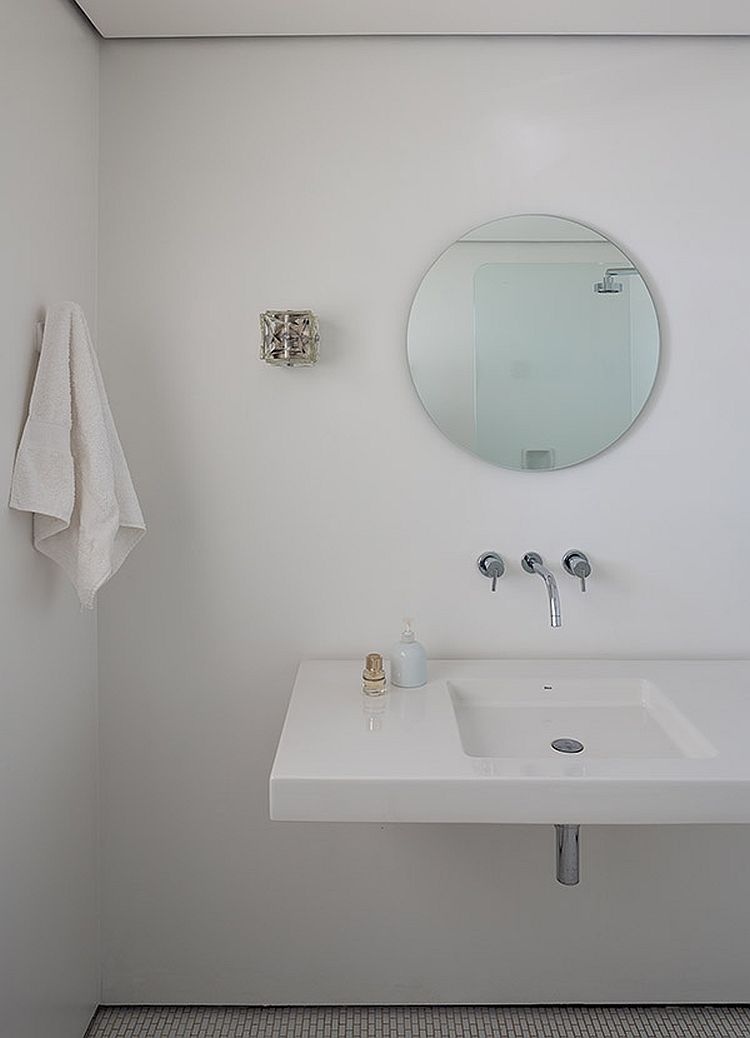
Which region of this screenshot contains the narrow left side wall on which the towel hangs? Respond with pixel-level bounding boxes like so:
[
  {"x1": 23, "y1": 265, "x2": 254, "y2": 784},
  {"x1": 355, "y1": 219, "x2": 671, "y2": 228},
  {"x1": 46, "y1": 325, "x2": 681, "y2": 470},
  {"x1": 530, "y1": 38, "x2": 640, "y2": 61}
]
[{"x1": 0, "y1": 0, "x2": 99, "y2": 1038}]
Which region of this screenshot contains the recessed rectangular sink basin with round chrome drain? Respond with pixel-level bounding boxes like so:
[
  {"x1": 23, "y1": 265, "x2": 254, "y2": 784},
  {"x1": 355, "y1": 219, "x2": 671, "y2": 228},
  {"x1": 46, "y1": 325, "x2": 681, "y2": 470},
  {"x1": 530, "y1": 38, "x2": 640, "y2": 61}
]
[{"x1": 447, "y1": 671, "x2": 716, "y2": 760}]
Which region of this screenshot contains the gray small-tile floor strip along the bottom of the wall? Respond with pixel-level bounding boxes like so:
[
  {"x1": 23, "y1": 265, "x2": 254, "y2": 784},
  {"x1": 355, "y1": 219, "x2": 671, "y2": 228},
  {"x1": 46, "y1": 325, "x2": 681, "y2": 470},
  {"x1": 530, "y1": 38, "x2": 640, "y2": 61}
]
[{"x1": 86, "y1": 1006, "x2": 750, "y2": 1038}]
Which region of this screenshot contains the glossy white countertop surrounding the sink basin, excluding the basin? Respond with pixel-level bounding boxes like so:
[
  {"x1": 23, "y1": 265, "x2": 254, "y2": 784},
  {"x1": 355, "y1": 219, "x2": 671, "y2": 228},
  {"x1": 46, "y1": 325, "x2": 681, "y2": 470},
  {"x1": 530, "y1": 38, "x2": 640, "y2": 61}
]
[{"x1": 270, "y1": 660, "x2": 750, "y2": 825}]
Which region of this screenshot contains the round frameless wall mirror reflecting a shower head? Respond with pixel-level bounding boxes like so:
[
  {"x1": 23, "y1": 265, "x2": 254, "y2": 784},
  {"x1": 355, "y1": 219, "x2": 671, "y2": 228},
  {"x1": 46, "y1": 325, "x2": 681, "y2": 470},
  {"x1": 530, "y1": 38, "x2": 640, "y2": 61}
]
[{"x1": 408, "y1": 216, "x2": 659, "y2": 469}]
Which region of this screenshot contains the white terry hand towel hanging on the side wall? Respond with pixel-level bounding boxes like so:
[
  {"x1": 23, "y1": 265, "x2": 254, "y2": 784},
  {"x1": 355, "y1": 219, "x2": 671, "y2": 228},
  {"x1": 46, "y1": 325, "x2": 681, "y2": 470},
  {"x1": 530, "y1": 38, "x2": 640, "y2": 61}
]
[{"x1": 10, "y1": 303, "x2": 146, "y2": 608}]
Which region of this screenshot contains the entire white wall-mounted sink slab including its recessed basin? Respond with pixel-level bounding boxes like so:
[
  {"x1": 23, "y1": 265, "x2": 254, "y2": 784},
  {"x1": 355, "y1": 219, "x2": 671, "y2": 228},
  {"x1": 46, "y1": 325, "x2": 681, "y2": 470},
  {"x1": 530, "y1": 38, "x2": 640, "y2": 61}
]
[{"x1": 271, "y1": 660, "x2": 750, "y2": 825}]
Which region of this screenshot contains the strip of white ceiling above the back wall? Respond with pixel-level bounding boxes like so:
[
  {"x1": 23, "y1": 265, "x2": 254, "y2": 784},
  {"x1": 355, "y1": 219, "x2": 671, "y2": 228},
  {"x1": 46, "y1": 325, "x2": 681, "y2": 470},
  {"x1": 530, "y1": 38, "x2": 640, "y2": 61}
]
[{"x1": 76, "y1": 0, "x2": 750, "y2": 38}]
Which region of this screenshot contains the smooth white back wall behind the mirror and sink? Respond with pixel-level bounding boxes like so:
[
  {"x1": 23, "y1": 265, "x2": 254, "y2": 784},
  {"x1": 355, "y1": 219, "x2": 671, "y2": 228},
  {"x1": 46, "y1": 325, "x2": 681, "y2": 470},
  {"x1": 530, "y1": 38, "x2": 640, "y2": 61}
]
[{"x1": 100, "y1": 39, "x2": 750, "y2": 1003}]
